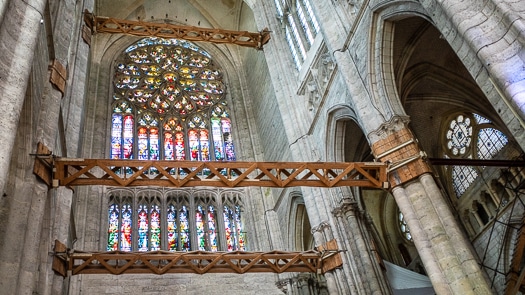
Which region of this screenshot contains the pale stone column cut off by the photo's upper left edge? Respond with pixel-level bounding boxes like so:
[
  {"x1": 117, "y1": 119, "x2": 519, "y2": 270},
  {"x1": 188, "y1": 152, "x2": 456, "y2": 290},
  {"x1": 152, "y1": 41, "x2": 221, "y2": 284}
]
[{"x1": 0, "y1": 0, "x2": 46, "y2": 194}]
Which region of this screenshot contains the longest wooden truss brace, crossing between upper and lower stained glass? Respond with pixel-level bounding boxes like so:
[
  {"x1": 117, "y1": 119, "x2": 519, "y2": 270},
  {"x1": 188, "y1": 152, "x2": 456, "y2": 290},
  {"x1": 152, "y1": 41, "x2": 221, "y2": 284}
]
[{"x1": 53, "y1": 158, "x2": 388, "y2": 188}]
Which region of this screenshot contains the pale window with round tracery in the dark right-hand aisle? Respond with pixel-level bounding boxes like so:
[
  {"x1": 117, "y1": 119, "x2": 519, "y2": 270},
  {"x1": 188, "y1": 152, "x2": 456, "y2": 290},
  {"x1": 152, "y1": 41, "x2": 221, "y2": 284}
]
[{"x1": 444, "y1": 113, "x2": 508, "y2": 198}]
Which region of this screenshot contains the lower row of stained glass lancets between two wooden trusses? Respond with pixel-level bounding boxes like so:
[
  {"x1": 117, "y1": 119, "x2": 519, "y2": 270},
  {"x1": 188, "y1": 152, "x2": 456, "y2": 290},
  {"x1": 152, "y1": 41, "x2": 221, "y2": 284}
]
[{"x1": 107, "y1": 189, "x2": 246, "y2": 251}]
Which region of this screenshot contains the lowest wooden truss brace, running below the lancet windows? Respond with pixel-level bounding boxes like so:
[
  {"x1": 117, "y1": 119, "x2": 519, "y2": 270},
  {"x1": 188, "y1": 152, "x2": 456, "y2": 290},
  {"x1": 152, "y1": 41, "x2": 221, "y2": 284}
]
[{"x1": 53, "y1": 240, "x2": 341, "y2": 277}]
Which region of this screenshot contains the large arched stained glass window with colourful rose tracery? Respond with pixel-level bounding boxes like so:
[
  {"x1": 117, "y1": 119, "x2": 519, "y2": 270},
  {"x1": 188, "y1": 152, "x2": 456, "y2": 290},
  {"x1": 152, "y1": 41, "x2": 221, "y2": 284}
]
[{"x1": 110, "y1": 38, "x2": 235, "y2": 161}]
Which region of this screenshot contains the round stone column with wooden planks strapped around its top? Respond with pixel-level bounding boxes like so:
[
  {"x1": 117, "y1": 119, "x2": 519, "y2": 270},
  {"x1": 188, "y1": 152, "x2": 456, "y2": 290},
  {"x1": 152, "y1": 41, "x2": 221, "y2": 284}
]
[{"x1": 369, "y1": 117, "x2": 492, "y2": 294}]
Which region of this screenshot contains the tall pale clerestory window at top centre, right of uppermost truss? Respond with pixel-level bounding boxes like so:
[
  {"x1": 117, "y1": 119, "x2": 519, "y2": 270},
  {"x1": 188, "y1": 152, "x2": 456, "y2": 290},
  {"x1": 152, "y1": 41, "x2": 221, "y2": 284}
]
[{"x1": 274, "y1": 0, "x2": 319, "y2": 69}]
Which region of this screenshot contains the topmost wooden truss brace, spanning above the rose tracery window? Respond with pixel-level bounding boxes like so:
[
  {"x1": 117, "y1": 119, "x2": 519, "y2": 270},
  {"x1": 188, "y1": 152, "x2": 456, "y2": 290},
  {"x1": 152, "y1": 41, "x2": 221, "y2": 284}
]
[{"x1": 84, "y1": 10, "x2": 270, "y2": 49}]
